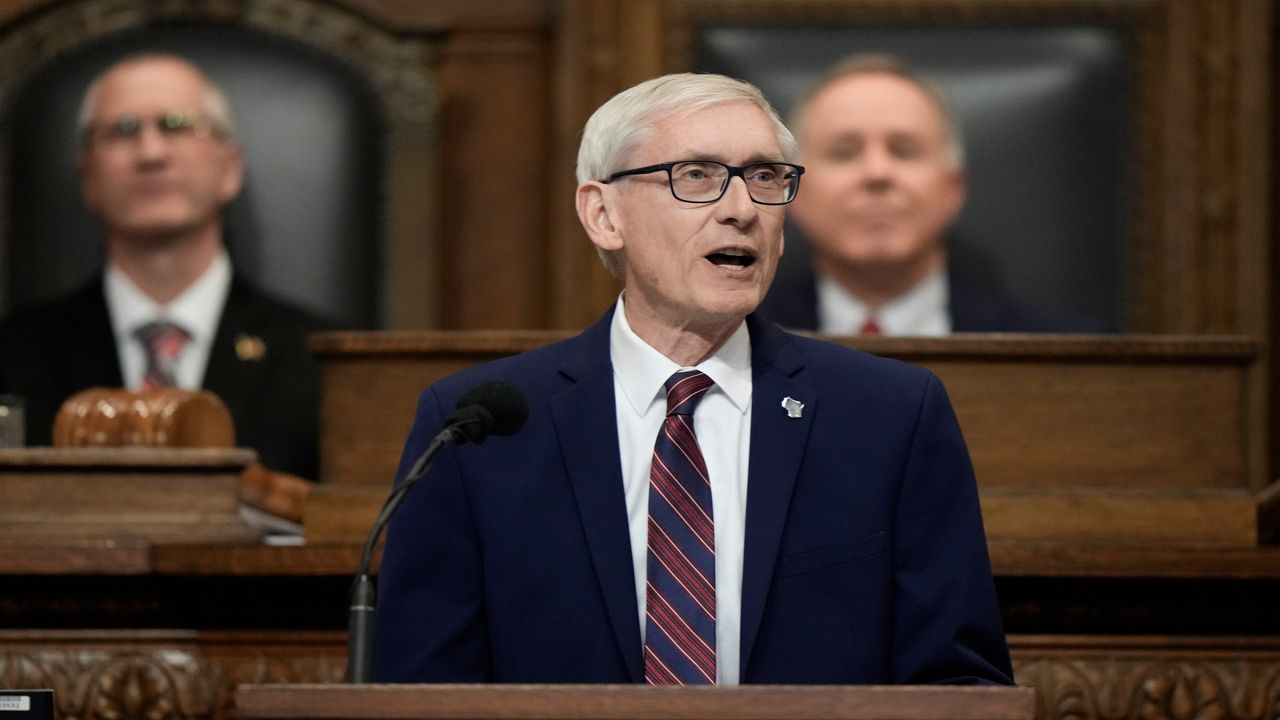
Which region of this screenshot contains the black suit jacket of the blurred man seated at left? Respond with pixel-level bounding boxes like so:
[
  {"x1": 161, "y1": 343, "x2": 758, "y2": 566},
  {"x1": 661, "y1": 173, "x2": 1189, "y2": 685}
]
[{"x1": 0, "y1": 275, "x2": 324, "y2": 479}]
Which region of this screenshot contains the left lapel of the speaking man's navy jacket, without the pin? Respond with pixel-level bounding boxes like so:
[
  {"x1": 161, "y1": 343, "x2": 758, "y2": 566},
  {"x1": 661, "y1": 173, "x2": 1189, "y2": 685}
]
[{"x1": 550, "y1": 311, "x2": 643, "y2": 682}]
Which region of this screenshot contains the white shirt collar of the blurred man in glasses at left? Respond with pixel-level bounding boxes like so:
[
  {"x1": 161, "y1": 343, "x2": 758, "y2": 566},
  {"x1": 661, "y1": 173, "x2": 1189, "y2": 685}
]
[{"x1": 102, "y1": 249, "x2": 232, "y2": 342}]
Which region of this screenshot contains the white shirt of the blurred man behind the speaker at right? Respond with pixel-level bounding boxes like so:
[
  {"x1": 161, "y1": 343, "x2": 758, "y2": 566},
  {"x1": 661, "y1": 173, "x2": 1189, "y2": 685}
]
[{"x1": 818, "y1": 270, "x2": 951, "y2": 337}]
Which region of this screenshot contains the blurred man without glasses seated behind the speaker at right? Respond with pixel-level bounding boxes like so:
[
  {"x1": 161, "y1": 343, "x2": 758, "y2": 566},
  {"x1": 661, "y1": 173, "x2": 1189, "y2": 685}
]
[{"x1": 759, "y1": 55, "x2": 1101, "y2": 336}]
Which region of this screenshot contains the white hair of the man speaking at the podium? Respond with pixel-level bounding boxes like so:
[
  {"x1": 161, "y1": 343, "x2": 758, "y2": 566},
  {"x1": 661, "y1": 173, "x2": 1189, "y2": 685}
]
[{"x1": 577, "y1": 73, "x2": 796, "y2": 277}]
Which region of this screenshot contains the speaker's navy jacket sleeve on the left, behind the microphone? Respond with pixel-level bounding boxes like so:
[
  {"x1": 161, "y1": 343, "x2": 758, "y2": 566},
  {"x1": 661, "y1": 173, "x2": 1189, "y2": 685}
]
[{"x1": 374, "y1": 389, "x2": 492, "y2": 683}]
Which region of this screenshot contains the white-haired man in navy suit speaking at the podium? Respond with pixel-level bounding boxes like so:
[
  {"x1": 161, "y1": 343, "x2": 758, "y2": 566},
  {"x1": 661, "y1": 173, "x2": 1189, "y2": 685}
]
[{"x1": 375, "y1": 74, "x2": 1012, "y2": 684}]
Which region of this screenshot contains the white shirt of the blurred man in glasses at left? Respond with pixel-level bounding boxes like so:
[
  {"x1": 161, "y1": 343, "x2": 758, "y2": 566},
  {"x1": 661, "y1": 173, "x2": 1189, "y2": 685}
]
[{"x1": 102, "y1": 250, "x2": 232, "y2": 389}]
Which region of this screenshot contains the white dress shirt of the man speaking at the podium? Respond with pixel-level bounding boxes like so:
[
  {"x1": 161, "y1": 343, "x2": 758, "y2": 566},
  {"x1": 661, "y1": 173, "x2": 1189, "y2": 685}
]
[{"x1": 609, "y1": 297, "x2": 751, "y2": 685}]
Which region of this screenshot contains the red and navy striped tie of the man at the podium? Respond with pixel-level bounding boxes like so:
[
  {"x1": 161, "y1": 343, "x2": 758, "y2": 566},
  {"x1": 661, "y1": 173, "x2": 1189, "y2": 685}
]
[{"x1": 644, "y1": 370, "x2": 716, "y2": 685}]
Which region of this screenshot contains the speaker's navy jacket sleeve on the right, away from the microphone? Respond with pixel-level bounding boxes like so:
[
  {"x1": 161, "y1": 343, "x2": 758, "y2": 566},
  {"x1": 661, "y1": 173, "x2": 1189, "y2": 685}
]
[{"x1": 892, "y1": 374, "x2": 1014, "y2": 684}]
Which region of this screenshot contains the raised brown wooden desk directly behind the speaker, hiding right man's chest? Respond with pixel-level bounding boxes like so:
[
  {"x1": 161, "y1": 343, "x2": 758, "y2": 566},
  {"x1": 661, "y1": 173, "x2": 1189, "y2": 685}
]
[{"x1": 311, "y1": 332, "x2": 1280, "y2": 546}]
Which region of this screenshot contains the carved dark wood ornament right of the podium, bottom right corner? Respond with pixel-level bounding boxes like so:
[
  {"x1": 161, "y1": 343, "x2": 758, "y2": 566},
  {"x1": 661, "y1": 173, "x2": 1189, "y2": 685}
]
[{"x1": 1014, "y1": 653, "x2": 1280, "y2": 720}]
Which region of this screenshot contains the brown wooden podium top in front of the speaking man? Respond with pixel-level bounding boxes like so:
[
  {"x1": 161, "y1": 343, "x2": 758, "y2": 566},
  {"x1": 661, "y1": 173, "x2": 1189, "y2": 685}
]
[{"x1": 236, "y1": 684, "x2": 1036, "y2": 720}]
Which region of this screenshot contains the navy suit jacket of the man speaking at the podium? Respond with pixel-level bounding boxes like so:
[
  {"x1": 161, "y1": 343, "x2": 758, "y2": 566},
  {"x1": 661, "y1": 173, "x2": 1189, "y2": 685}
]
[{"x1": 375, "y1": 304, "x2": 1011, "y2": 683}]
